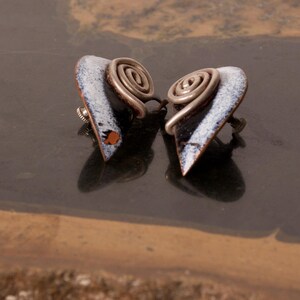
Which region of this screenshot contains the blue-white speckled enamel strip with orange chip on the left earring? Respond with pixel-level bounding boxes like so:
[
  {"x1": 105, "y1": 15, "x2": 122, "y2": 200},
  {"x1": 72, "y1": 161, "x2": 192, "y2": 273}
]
[{"x1": 75, "y1": 55, "x2": 130, "y2": 160}]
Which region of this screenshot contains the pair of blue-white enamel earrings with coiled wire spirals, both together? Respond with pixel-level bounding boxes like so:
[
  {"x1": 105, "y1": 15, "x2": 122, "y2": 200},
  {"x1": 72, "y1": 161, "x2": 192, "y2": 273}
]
[{"x1": 75, "y1": 56, "x2": 247, "y2": 176}]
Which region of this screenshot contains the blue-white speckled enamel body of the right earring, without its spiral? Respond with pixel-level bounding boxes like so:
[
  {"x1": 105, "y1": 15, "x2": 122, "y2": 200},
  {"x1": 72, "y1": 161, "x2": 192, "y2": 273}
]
[{"x1": 175, "y1": 67, "x2": 247, "y2": 175}]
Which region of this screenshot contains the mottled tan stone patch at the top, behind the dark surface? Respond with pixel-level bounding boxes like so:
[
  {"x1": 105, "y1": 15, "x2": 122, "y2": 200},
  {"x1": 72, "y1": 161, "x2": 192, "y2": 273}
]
[{"x1": 69, "y1": 0, "x2": 300, "y2": 41}]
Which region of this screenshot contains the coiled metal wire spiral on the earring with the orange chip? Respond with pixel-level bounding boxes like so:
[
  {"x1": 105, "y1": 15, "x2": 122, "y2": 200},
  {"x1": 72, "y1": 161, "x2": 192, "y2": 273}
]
[{"x1": 107, "y1": 58, "x2": 154, "y2": 118}]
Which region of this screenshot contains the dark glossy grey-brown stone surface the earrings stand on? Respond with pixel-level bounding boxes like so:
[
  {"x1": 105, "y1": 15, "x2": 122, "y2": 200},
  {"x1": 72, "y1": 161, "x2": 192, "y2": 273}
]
[{"x1": 0, "y1": 0, "x2": 300, "y2": 242}]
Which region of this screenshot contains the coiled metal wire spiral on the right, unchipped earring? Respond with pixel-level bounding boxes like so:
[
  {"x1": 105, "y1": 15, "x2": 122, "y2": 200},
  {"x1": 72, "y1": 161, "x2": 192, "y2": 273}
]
[{"x1": 165, "y1": 68, "x2": 220, "y2": 135}]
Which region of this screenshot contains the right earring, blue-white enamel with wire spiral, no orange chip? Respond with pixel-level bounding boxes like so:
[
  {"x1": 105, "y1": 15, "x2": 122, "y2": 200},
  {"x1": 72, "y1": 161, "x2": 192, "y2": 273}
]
[{"x1": 165, "y1": 67, "x2": 247, "y2": 176}]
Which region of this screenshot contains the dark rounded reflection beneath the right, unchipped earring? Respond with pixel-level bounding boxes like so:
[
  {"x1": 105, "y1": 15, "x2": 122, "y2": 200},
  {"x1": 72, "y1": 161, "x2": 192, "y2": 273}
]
[{"x1": 163, "y1": 131, "x2": 246, "y2": 202}]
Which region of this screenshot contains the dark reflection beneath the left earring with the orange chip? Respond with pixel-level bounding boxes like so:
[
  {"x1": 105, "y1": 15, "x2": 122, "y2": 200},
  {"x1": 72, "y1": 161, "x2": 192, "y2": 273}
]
[{"x1": 78, "y1": 110, "x2": 166, "y2": 192}]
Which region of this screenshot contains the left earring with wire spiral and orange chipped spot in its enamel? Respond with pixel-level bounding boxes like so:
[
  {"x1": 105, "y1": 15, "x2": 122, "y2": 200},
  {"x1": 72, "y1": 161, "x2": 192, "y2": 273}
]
[{"x1": 75, "y1": 56, "x2": 159, "y2": 161}]
